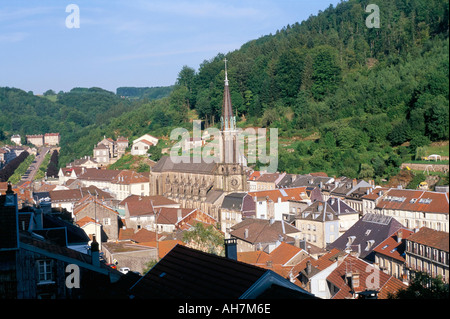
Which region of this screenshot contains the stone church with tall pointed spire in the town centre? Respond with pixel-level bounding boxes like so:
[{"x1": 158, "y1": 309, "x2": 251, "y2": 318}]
[{"x1": 150, "y1": 60, "x2": 247, "y2": 220}]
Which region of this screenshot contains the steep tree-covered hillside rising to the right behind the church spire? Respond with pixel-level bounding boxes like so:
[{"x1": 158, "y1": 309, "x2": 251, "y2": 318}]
[{"x1": 174, "y1": 0, "x2": 449, "y2": 178}]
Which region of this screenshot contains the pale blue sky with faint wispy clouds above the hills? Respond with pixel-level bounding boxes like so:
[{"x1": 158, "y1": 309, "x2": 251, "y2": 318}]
[{"x1": 0, "y1": 0, "x2": 340, "y2": 94}]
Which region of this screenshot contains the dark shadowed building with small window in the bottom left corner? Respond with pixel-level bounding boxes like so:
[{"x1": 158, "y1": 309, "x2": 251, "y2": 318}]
[{"x1": 0, "y1": 187, "x2": 125, "y2": 299}]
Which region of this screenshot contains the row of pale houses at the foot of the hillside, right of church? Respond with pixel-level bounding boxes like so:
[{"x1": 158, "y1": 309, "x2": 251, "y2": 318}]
[{"x1": 248, "y1": 172, "x2": 449, "y2": 232}]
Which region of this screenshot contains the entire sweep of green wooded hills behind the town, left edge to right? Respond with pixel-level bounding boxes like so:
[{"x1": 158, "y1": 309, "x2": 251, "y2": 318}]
[{"x1": 0, "y1": 0, "x2": 449, "y2": 179}]
